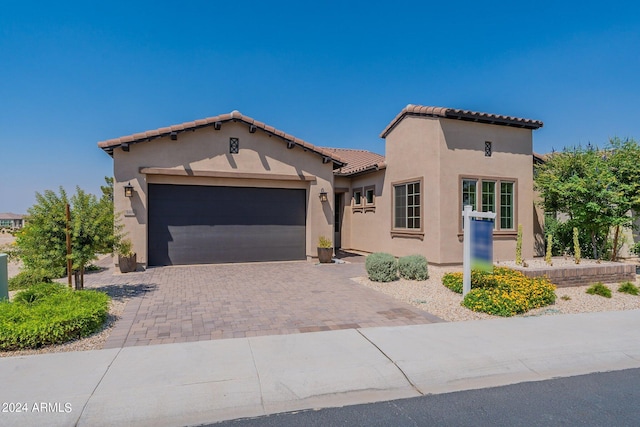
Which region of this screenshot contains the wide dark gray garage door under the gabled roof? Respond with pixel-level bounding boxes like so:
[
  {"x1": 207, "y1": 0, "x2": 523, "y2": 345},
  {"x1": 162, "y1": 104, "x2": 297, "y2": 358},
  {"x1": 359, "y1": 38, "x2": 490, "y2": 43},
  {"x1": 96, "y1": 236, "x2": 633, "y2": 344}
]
[{"x1": 147, "y1": 184, "x2": 306, "y2": 265}]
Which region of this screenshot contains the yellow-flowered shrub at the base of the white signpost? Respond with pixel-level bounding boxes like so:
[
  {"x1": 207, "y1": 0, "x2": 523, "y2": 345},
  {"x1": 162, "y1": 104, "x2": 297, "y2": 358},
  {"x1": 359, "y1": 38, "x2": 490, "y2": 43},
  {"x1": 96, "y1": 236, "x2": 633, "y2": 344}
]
[{"x1": 442, "y1": 267, "x2": 556, "y2": 316}]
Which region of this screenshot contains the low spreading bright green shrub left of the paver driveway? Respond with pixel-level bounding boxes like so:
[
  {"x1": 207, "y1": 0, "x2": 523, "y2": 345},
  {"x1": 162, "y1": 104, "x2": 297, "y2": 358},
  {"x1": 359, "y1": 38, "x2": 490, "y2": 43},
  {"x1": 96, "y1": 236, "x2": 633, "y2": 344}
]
[{"x1": 0, "y1": 285, "x2": 109, "y2": 350}]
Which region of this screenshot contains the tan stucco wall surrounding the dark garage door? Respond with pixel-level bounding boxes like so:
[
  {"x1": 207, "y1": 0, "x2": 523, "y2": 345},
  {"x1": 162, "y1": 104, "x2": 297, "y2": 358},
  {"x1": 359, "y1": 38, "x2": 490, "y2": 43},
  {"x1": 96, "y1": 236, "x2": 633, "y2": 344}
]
[{"x1": 113, "y1": 122, "x2": 334, "y2": 264}]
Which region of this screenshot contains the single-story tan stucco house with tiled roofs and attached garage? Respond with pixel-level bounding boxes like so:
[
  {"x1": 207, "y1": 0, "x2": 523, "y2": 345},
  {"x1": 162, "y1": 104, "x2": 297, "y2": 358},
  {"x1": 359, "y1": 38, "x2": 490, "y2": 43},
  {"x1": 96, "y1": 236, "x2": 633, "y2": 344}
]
[{"x1": 98, "y1": 105, "x2": 543, "y2": 266}]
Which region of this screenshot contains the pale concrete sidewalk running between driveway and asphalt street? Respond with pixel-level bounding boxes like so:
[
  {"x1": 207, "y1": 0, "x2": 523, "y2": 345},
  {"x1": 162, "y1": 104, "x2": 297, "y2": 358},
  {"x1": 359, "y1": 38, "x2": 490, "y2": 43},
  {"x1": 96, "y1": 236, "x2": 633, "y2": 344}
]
[{"x1": 0, "y1": 310, "x2": 640, "y2": 426}]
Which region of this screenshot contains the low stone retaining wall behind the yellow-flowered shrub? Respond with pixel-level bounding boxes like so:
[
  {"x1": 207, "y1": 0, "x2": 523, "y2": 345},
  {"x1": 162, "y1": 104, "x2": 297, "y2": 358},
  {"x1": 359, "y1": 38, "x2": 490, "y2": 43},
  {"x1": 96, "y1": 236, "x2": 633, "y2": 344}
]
[{"x1": 511, "y1": 262, "x2": 636, "y2": 288}]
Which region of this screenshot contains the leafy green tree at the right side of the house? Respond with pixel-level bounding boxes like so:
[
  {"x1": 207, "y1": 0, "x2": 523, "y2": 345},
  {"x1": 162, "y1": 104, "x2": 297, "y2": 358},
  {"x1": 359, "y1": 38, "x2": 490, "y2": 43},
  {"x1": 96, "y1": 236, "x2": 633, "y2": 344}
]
[{"x1": 535, "y1": 139, "x2": 640, "y2": 259}]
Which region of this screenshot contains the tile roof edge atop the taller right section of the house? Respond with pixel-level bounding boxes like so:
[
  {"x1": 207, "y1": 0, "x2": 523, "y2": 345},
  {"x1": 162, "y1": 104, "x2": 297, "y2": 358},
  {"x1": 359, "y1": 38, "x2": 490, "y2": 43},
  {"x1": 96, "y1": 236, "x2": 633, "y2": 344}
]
[{"x1": 380, "y1": 104, "x2": 543, "y2": 138}]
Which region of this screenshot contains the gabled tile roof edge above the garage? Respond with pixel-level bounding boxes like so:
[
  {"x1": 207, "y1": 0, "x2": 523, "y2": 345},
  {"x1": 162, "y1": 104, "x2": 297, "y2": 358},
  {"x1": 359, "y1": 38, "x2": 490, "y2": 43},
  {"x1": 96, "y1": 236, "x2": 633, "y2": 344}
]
[{"x1": 98, "y1": 110, "x2": 346, "y2": 166}]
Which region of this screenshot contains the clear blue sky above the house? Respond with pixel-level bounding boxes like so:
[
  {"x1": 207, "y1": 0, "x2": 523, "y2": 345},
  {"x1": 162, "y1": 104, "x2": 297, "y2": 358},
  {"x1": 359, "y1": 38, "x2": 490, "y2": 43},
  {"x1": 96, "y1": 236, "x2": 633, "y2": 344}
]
[{"x1": 0, "y1": 0, "x2": 640, "y2": 213}]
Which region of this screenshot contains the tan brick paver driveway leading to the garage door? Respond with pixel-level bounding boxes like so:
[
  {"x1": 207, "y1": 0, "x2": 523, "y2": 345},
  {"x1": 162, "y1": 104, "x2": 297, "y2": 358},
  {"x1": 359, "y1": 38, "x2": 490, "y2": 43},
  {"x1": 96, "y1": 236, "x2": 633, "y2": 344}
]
[{"x1": 85, "y1": 261, "x2": 442, "y2": 348}]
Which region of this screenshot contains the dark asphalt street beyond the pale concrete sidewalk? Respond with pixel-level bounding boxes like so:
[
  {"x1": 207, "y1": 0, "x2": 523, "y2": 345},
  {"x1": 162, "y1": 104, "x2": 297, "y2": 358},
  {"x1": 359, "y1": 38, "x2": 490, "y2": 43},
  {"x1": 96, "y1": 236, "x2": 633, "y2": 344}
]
[{"x1": 211, "y1": 369, "x2": 640, "y2": 427}]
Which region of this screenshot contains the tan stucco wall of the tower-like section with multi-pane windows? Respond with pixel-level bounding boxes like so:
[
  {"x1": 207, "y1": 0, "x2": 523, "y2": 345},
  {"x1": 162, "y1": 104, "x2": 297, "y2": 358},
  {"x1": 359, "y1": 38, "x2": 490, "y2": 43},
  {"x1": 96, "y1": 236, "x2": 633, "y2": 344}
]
[{"x1": 344, "y1": 116, "x2": 534, "y2": 264}]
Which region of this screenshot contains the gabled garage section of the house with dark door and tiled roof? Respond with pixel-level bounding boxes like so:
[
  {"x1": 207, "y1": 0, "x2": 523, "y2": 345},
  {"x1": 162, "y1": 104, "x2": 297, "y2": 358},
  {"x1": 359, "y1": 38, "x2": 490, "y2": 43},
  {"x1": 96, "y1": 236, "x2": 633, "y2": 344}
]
[{"x1": 98, "y1": 111, "x2": 346, "y2": 268}]
